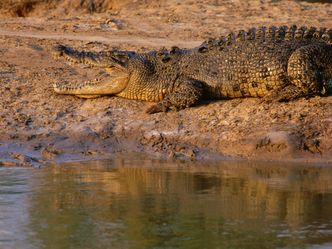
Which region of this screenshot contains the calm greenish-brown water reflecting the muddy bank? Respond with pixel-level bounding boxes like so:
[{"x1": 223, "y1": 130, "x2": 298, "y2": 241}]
[{"x1": 0, "y1": 159, "x2": 332, "y2": 249}]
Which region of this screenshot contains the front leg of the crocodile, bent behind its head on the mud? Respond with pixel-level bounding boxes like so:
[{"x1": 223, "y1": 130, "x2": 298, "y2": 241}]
[{"x1": 146, "y1": 77, "x2": 203, "y2": 114}]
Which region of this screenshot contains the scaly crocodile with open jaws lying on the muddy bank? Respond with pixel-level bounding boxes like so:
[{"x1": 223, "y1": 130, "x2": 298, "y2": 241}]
[{"x1": 53, "y1": 25, "x2": 332, "y2": 113}]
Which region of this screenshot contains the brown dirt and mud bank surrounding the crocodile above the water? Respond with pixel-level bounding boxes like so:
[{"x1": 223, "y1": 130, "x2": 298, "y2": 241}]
[{"x1": 0, "y1": 0, "x2": 332, "y2": 166}]
